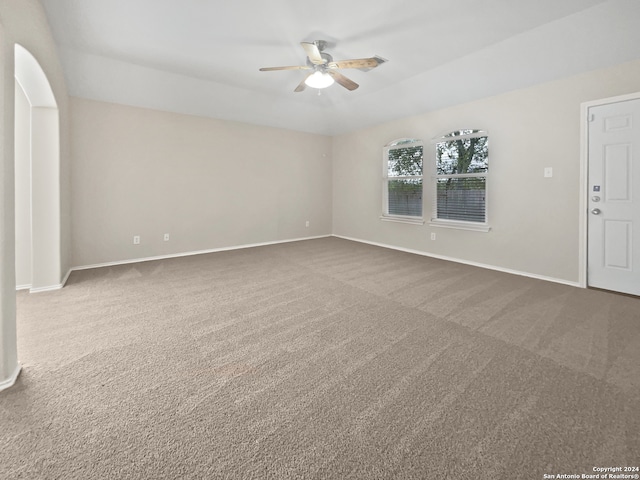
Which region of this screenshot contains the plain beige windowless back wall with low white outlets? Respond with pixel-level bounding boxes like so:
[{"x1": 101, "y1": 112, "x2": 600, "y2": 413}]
[{"x1": 71, "y1": 98, "x2": 332, "y2": 266}]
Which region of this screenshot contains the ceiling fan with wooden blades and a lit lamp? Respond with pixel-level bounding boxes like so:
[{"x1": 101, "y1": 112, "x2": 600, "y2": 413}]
[{"x1": 260, "y1": 40, "x2": 386, "y2": 93}]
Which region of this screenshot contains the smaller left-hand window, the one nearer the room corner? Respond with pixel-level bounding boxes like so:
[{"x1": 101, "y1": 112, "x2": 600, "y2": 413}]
[{"x1": 381, "y1": 138, "x2": 423, "y2": 223}]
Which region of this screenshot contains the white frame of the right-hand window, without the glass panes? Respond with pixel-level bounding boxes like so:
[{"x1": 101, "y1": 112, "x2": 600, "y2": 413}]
[{"x1": 429, "y1": 128, "x2": 491, "y2": 232}]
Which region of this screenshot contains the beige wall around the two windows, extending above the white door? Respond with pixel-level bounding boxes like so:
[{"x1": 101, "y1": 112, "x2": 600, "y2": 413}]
[{"x1": 333, "y1": 61, "x2": 640, "y2": 283}]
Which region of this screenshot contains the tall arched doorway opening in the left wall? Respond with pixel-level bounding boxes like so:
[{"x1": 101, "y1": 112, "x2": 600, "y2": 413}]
[{"x1": 15, "y1": 44, "x2": 61, "y2": 292}]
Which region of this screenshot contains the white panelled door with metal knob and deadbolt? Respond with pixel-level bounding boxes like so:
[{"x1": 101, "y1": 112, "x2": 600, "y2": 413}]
[{"x1": 587, "y1": 99, "x2": 640, "y2": 295}]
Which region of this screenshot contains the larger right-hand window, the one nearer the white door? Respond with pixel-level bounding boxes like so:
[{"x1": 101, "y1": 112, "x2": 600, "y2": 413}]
[{"x1": 431, "y1": 130, "x2": 489, "y2": 231}]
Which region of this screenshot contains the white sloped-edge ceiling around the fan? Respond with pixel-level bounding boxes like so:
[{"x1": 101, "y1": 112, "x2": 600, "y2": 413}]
[{"x1": 41, "y1": 0, "x2": 640, "y2": 135}]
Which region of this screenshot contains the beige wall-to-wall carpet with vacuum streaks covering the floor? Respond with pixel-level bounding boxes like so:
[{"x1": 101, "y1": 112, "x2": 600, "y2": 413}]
[{"x1": 0, "y1": 238, "x2": 640, "y2": 480}]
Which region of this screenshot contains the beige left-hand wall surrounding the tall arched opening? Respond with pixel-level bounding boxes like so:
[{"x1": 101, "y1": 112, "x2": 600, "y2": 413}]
[{"x1": 0, "y1": 0, "x2": 71, "y2": 388}]
